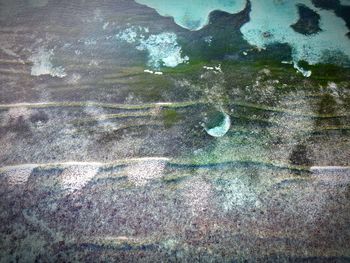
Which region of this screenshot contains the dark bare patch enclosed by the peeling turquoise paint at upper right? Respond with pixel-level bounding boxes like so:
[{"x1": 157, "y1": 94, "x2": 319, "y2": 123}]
[{"x1": 291, "y1": 4, "x2": 322, "y2": 35}]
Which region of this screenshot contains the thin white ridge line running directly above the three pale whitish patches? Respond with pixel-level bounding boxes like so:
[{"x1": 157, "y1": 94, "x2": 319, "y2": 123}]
[{"x1": 0, "y1": 157, "x2": 170, "y2": 172}]
